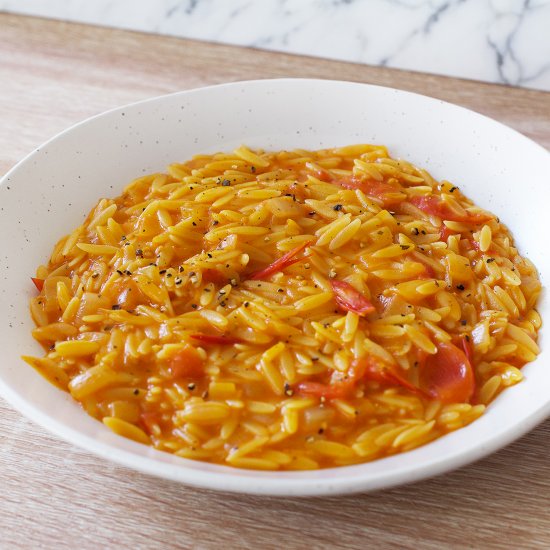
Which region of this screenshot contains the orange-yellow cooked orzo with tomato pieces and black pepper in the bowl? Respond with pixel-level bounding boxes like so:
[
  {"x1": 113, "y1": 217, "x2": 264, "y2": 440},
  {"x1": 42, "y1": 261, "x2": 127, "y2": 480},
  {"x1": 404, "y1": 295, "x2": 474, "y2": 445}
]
[{"x1": 25, "y1": 145, "x2": 541, "y2": 470}]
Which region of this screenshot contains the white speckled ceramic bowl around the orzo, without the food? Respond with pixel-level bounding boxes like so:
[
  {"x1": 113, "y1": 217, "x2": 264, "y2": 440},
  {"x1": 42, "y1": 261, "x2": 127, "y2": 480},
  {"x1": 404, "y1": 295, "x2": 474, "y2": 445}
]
[{"x1": 0, "y1": 79, "x2": 550, "y2": 495}]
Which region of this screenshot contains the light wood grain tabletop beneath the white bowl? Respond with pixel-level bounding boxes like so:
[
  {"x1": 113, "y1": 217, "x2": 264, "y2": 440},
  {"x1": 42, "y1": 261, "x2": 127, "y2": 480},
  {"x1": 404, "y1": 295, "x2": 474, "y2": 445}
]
[{"x1": 0, "y1": 14, "x2": 550, "y2": 549}]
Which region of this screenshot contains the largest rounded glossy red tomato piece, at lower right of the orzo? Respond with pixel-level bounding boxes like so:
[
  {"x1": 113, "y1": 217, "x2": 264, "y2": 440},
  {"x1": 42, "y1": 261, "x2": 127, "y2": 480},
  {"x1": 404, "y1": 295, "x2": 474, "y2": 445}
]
[{"x1": 420, "y1": 339, "x2": 475, "y2": 403}]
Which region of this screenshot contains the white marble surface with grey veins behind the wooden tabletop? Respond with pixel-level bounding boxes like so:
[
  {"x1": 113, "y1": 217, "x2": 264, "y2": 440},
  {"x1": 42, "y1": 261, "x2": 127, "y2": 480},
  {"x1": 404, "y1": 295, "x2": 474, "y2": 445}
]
[{"x1": 0, "y1": 0, "x2": 550, "y2": 91}]
